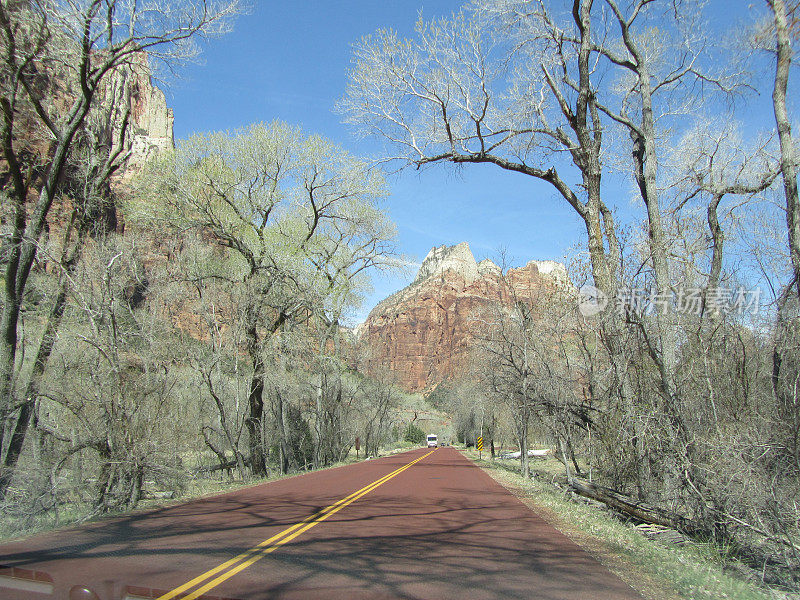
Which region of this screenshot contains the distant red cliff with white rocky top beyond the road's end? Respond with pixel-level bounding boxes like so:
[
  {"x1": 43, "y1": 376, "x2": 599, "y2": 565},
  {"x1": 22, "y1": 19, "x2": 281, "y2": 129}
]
[{"x1": 358, "y1": 242, "x2": 567, "y2": 392}]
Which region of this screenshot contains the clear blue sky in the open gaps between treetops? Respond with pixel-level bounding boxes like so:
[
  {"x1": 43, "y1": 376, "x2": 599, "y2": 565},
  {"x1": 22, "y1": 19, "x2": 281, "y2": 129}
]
[{"x1": 167, "y1": 0, "x2": 780, "y2": 320}]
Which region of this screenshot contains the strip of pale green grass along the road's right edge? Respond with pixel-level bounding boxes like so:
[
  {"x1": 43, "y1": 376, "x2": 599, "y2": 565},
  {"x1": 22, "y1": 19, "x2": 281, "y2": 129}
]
[{"x1": 464, "y1": 450, "x2": 800, "y2": 600}]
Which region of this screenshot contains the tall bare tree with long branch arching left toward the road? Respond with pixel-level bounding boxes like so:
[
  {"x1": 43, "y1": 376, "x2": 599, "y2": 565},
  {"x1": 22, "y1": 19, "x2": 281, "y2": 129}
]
[{"x1": 340, "y1": 2, "x2": 619, "y2": 294}]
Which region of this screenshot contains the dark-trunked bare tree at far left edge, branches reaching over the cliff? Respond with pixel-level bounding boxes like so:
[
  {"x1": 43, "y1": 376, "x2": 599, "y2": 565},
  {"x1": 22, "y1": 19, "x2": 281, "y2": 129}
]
[{"x1": 0, "y1": 0, "x2": 240, "y2": 496}]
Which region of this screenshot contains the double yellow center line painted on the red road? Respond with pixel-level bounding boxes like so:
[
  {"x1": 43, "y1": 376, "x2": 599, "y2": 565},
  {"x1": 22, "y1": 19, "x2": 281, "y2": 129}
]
[{"x1": 156, "y1": 450, "x2": 434, "y2": 600}]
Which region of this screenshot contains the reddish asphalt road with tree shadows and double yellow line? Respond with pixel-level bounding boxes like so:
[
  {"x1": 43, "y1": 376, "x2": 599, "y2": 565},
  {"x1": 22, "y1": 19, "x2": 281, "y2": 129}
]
[{"x1": 0, "y1": 448, "x2": 641, "y2": 600}]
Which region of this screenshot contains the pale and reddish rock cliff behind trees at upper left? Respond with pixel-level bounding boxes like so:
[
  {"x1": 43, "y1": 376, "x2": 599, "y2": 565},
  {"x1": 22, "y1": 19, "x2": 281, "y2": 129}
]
[{"x1": 0, "y1": 52, "x2": 174, "y2": 241}]
